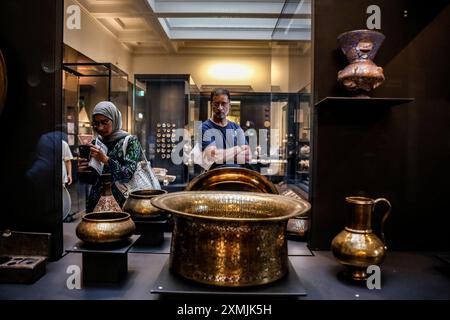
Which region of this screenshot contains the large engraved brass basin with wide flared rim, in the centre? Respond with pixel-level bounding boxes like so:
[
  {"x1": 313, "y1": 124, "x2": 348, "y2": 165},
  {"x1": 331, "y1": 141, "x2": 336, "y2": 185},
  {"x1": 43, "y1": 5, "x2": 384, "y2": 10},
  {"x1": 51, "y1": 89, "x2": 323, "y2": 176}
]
[{"x1": 152, "y1": 191, "x2": 310, "y2": 287}]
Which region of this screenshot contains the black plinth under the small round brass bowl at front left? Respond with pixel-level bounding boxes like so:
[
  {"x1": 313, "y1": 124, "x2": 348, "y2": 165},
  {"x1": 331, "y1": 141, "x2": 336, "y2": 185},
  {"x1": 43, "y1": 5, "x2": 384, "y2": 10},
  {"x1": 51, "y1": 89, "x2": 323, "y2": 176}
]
[{"x1": 67, "y1": 235, "x2": 139, "y2": 283}]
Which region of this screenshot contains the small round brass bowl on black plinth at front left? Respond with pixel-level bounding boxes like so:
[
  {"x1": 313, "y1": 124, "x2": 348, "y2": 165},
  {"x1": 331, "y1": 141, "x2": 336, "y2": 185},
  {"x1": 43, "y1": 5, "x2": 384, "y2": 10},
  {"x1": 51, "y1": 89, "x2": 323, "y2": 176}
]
[{"x1": 76, "y1": 211, "x2": 135, "y2": 244}]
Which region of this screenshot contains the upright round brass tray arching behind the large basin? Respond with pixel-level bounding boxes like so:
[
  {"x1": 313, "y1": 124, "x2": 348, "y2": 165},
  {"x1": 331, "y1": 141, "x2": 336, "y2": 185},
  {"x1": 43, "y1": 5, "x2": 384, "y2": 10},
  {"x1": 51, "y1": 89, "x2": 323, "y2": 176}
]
[{"x1": 185, "y1": 167, "x2": 279, "y2": 194}]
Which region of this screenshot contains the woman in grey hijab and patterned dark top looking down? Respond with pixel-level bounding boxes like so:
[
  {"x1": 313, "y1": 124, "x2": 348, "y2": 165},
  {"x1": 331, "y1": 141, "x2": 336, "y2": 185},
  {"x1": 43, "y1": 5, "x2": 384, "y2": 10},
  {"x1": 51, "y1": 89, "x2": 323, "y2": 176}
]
[{"x1": 79, "y1": 101, "x2": 141, "y2": 212}]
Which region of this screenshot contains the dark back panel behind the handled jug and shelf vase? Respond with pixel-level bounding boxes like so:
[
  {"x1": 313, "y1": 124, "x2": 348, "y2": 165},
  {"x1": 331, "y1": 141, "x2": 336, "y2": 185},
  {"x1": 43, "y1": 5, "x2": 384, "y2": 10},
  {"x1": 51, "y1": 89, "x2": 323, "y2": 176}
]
[{"x1": 310, "y1": 0, "x2": 450, "y2": 251}]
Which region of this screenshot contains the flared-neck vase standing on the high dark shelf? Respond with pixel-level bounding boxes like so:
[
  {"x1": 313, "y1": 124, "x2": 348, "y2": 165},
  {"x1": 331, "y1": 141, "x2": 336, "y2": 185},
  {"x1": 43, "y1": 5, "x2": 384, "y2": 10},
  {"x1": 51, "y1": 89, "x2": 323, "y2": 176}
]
[{"x1": 337, "y1": 30, "x2": 385, "y2": 96}]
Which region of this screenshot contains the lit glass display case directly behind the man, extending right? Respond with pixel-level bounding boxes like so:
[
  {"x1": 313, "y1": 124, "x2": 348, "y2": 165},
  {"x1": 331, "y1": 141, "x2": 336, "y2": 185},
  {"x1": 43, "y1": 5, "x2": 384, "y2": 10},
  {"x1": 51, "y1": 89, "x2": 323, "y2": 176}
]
[{"x1": 186, "y1": 91, "x2": 310, "y2": 192}]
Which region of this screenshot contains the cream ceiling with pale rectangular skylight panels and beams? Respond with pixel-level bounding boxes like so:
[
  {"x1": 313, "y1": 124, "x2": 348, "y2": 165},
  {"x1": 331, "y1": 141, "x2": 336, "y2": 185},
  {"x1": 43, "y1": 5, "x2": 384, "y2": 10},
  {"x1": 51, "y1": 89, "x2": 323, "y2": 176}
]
[{"x1": 78, "y1": 0, "x2": 311, "y2": 55}]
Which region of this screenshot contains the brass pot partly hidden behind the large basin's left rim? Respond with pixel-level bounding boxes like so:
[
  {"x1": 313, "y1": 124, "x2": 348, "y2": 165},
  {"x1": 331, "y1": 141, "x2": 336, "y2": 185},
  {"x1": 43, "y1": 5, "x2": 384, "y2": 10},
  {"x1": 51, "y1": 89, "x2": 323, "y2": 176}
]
[{"x1": 122, "y1": 189, "x2": 167, "y2": 219}]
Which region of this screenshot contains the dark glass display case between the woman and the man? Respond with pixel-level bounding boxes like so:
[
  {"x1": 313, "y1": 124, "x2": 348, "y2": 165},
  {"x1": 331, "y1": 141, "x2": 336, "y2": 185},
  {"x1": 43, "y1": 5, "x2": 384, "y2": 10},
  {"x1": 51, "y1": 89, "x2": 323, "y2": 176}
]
[{"x1": 133, "y1": 74, "x2": 199, "y2": 189}]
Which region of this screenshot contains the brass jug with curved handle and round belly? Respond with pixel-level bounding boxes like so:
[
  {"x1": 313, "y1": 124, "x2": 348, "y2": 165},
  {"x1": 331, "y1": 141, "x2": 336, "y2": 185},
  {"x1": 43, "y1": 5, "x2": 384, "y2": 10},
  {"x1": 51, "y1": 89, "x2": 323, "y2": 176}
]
[{"x1": 331, "y1": 197, "x2": 391, "y2": 280}]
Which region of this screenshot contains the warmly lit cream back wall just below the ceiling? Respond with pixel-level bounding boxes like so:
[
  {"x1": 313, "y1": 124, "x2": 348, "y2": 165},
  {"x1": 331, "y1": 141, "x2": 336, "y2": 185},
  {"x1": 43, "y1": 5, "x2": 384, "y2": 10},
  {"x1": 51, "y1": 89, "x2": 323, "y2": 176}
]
[{"x1": 133, "y1": 50, "x2": 311, "y2": 92}]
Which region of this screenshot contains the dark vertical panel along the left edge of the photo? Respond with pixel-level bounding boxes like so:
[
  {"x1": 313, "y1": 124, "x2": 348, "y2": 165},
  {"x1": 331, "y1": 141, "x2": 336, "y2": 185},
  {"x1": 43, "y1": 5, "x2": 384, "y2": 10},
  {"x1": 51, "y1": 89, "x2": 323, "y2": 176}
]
[{"x1": 0, "y1": 0, "x2": 64, "y2": 258}]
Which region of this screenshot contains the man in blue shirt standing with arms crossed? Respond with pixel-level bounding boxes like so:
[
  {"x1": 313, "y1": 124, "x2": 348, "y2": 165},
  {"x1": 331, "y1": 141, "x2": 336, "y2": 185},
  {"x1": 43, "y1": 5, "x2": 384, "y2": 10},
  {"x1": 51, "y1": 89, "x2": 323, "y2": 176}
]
[{"x1": 201, "y1": 88, "x2": 250, "y2": 169}]
